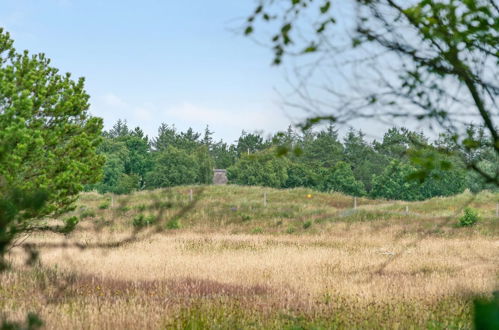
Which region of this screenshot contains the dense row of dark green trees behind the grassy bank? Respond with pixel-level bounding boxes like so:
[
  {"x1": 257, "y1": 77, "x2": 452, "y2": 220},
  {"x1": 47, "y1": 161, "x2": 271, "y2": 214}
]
[{"x1": 86, "y1": 120, "x2": 497, "y2": 200}]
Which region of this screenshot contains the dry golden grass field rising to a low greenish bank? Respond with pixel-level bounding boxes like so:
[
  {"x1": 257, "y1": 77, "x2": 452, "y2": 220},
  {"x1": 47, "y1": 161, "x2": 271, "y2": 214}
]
[{"x1": 0, "y1": 186, "x2": 499, "y2": 329}]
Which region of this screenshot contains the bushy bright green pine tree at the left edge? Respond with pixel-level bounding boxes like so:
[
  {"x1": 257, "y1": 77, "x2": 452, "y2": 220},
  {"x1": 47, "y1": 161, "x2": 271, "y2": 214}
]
[{"x1": 0, "y1": 29, "x2": 103, "y2": 218}]
